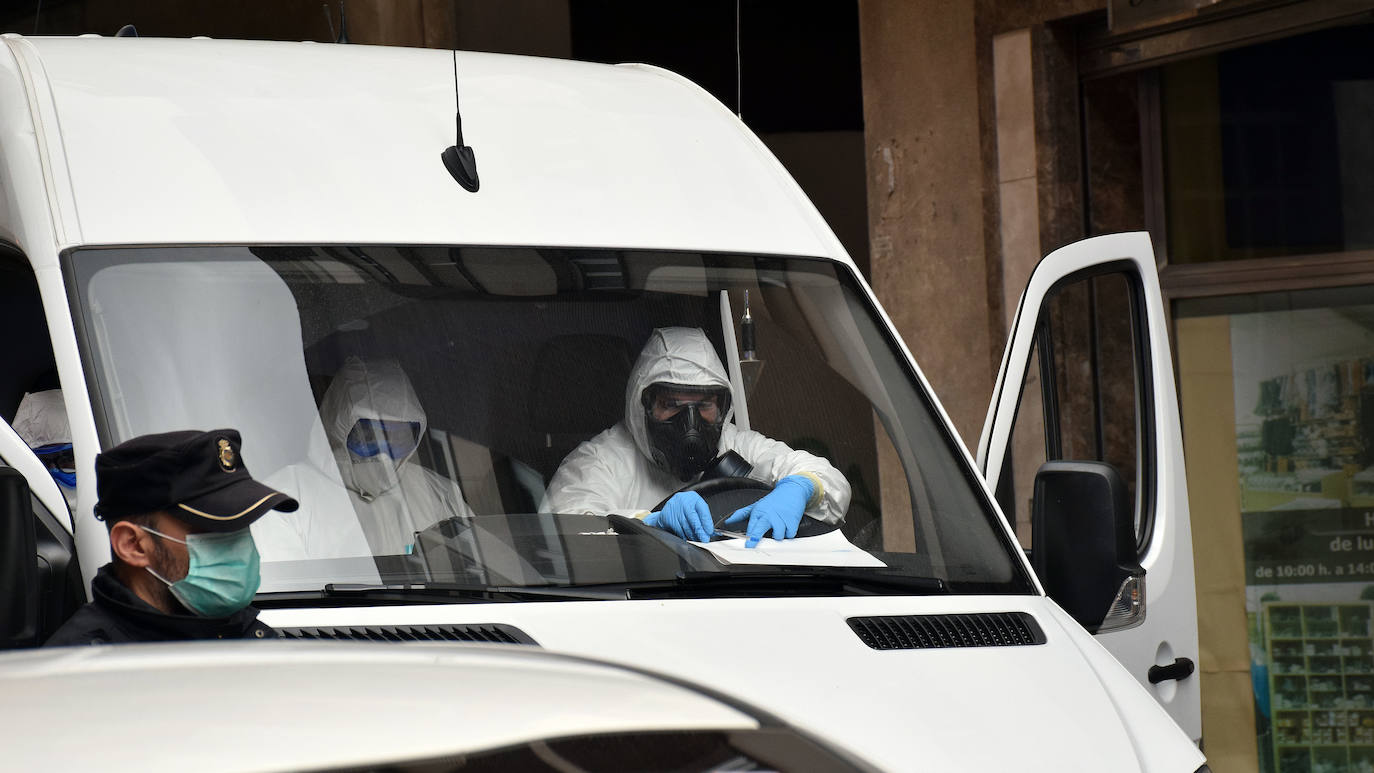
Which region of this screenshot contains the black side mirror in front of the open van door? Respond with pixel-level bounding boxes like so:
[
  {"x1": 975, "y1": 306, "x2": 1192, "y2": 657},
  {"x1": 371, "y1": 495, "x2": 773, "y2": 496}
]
[{"x1": 1031, "y1": 461, "x2": 1145, "y2": 632}]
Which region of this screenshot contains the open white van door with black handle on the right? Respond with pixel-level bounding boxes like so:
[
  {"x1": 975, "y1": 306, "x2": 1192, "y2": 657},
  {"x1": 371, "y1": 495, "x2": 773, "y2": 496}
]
[{"x1": 978, "y1": 233, "x2": 1202, "y2": 740}]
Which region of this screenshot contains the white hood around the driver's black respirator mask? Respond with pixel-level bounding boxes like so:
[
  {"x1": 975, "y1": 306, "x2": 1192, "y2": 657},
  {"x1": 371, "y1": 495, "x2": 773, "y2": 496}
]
[{"x1": 625, "y1": 327, "x2": 735, "y2": 459}]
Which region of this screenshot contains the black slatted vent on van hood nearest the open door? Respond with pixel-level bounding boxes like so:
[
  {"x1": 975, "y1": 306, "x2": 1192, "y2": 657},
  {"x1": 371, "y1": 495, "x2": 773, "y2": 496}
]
[{"x1": 848, "y1": 612, "x2": 1044, "y2": 649}]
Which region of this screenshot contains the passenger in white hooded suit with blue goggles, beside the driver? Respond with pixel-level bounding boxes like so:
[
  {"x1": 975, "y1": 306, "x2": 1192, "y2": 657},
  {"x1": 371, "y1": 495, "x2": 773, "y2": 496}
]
[{"x1": 320, "y1": 357, "x2": 473, "y2": 556}]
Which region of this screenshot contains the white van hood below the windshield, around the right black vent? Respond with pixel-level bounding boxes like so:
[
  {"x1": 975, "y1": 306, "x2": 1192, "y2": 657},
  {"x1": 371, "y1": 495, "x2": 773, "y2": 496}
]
[{"x1": 262, "y1": 596, "x2": 1204, "y2": 773}]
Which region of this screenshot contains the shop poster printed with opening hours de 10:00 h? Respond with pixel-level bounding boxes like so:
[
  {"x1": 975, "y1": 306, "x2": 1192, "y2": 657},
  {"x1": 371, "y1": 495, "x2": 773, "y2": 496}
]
[{"x1": 1231, "y1": 306, "x2": 1374, "y2": 773}]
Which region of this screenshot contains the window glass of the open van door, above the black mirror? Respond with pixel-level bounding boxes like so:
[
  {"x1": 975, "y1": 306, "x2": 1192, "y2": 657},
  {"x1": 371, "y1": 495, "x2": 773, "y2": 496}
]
[{"x1": 998, "y1": 273, "x2": 1151, "y2": 546}]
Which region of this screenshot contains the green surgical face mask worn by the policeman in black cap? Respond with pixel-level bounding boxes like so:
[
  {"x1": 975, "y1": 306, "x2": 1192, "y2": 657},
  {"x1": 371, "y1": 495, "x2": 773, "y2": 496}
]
[{"x1": 143, "y1": 526, "x2": 262, "y2": 618}]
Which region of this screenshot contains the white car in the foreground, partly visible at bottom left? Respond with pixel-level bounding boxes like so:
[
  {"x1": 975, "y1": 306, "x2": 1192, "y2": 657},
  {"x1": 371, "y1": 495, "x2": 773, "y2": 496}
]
[{"x1": 0, "y1": 641, "x2": 874, "y2": 773}]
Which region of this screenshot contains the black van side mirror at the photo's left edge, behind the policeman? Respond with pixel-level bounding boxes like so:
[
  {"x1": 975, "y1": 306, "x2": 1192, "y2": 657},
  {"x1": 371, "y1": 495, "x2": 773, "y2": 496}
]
[{"x1": 0, "y1": 467, "x2": 38, "y2": 649}]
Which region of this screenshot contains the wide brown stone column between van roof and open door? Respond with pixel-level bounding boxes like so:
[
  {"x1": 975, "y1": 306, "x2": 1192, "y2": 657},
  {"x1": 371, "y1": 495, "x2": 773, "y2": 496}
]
[{"x1": 859, "y1": 0, "x2": 1002, "y2": 446}]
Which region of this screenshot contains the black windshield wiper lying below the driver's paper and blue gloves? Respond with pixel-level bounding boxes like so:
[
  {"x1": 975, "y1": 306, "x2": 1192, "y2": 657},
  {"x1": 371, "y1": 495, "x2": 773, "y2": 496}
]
[{"x1": 596, "y1": 567, "x2": 945, "y2": 599}]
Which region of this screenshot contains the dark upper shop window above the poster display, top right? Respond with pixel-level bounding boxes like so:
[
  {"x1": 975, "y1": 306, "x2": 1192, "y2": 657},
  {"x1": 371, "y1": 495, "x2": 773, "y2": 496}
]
[{"x1": 1161, "y1": 25, "x2": 1374, "y2": 264}]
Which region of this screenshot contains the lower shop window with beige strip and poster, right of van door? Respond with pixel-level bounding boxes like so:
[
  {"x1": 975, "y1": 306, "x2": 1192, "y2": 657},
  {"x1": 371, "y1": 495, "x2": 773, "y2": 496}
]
[{"x1": 1175, "y1": 287, "x2": 1374, "y2": 772}]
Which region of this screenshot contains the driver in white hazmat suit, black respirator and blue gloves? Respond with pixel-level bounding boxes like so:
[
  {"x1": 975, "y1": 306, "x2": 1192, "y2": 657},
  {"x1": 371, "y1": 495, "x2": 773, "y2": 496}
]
[{"x1": 540, "y1": 327, "x2": 849, "y2": 546}]
